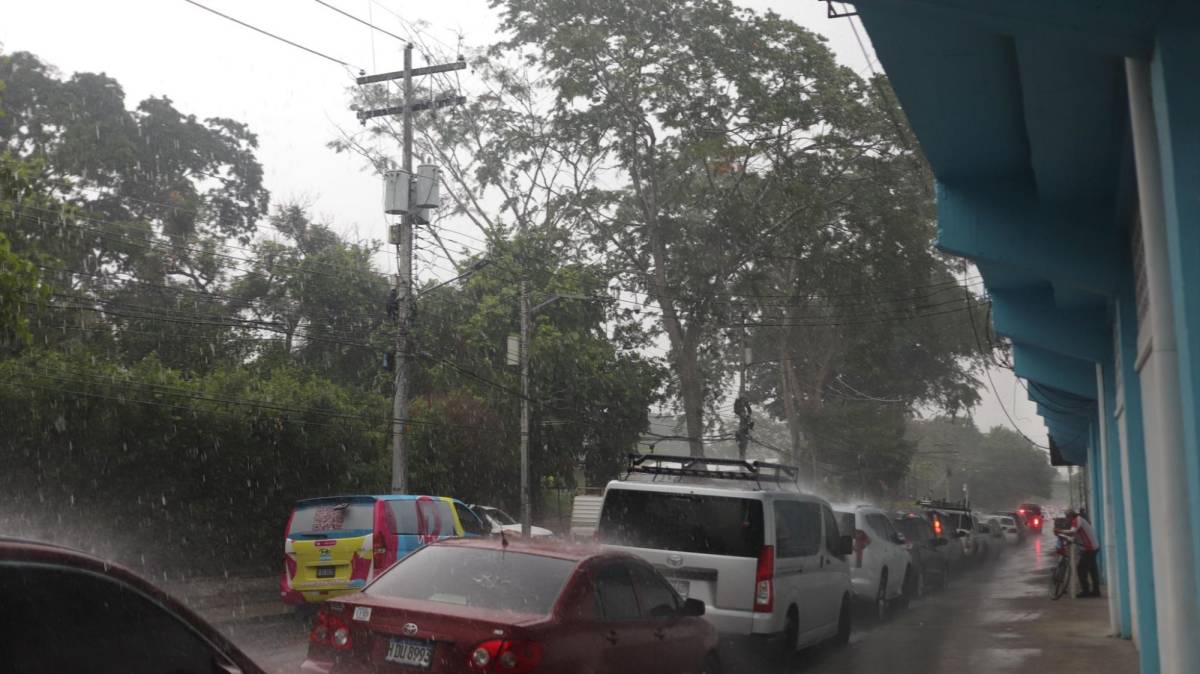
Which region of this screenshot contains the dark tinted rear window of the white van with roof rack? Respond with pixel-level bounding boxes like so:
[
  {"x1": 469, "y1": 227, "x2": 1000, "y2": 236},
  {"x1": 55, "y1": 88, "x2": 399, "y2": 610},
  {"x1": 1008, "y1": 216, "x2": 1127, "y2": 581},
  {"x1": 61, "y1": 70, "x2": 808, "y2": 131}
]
[{"x1": 598, "y1": 489, "x2": 763, "y2": 558}]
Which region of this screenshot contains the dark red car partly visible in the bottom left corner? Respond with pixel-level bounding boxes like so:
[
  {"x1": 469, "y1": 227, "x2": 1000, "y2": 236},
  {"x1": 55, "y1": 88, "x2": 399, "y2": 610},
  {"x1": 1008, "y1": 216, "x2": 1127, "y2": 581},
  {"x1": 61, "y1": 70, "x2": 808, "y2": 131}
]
[{"x1": 0, "y1": 538, "x2": 263, "y2": 674}]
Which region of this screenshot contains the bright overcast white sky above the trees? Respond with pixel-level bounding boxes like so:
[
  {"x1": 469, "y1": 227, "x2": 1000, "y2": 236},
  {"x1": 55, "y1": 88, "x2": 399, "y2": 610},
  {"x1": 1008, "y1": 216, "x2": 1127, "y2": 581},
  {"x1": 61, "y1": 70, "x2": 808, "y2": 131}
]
[{"x1": 0, "y1": 0, "x2": 1045, "y2": 443}]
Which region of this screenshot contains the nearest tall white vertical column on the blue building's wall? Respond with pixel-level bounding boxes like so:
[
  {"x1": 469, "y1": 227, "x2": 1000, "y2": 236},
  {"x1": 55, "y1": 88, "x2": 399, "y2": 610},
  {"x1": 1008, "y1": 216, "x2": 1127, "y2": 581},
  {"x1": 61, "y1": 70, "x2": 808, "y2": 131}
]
[{"x1": 1126, "y1": 59, "x2": 1200, "y2": 674}]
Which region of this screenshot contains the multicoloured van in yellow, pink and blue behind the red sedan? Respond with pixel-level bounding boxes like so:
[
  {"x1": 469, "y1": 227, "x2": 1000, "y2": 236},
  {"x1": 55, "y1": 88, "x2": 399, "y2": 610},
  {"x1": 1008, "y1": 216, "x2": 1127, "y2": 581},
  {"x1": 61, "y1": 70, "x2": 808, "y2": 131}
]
[{"x1": 280, "y1": 494, "x2": 491, "y2": 606}]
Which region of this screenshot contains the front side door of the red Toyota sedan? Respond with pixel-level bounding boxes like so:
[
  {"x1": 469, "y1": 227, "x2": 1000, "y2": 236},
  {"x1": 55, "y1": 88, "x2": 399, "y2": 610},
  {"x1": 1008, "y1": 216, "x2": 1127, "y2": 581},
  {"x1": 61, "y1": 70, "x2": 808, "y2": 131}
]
[{"x1": 629, "y1": 561, "x2": 686, "y2": 674}]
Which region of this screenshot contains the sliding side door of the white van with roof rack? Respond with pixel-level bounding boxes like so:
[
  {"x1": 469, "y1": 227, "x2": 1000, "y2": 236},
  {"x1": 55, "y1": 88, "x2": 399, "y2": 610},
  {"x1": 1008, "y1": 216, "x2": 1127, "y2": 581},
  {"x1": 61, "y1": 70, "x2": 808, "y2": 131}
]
[{"x1": 774, "y1": 500, "x2": 827, "y2": 643}]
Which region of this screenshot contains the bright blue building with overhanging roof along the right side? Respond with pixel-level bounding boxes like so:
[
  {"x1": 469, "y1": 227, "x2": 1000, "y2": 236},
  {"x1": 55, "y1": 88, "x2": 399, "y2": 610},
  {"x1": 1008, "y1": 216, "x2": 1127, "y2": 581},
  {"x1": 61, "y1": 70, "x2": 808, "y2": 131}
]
[{"x1": 856, "y1": 0, "x2": 1200, "y2": 674}]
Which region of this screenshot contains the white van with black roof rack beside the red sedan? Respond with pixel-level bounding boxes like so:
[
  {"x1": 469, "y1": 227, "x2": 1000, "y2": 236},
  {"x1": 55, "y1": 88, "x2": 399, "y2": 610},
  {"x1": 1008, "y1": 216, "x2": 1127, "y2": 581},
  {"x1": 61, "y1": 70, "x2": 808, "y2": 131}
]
[{"x1": 596, "y1": 455, "x2": 853, "y2": 650}]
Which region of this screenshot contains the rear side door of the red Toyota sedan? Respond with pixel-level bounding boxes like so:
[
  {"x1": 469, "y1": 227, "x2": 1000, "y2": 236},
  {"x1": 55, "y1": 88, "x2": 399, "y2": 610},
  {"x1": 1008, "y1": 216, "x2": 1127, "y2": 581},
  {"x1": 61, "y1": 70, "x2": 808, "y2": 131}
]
[{"x1": 593, "y1": 561, "x2": 650, "y2": 674}]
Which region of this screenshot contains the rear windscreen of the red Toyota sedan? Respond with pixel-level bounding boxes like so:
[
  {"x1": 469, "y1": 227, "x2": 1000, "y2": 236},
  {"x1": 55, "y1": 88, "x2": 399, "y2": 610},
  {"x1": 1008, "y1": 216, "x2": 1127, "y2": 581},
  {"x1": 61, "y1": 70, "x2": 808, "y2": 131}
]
[{"x1": 365, "y1": 546, "x2": 577, "y2": 615}]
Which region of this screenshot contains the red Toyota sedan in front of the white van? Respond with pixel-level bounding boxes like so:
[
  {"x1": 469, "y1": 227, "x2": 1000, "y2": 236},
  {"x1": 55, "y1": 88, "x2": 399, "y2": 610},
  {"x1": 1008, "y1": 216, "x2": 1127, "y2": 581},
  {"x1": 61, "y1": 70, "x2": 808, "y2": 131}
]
[{"x1": 302, "y1": 538, "x2": 720, "y2": 674}]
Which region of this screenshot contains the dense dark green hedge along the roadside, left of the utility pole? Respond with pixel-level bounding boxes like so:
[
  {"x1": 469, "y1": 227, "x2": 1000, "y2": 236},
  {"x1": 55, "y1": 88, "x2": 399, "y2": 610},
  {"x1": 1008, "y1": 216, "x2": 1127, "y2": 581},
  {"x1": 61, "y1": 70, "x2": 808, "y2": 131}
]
[{"x1": 0, "y1": 350, "x2": 385, "y2": 572}]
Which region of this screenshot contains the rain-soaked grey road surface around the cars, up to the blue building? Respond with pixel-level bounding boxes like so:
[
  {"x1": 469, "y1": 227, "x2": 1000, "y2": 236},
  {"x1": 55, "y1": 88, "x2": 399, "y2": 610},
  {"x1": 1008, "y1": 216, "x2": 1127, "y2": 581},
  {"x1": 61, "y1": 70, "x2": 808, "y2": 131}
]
[{"x1": 230, "y1": 534, "x2": 1138, "y2": 674}]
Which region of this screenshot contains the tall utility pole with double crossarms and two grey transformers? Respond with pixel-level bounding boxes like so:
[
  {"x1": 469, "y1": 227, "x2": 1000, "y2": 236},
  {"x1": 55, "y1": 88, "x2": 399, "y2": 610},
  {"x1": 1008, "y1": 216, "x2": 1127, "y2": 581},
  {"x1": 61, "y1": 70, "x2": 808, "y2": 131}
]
[{"x1": 356, "y1": 42, "x2": 467, "y2": 494}]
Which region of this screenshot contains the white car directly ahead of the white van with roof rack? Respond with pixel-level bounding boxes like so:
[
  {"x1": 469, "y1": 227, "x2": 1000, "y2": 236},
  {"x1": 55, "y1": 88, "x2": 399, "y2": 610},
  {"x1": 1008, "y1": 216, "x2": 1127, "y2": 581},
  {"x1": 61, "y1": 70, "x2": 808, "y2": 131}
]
[{"x1": 835, "y1": 505, "x2": 916, "y2": 619}]
